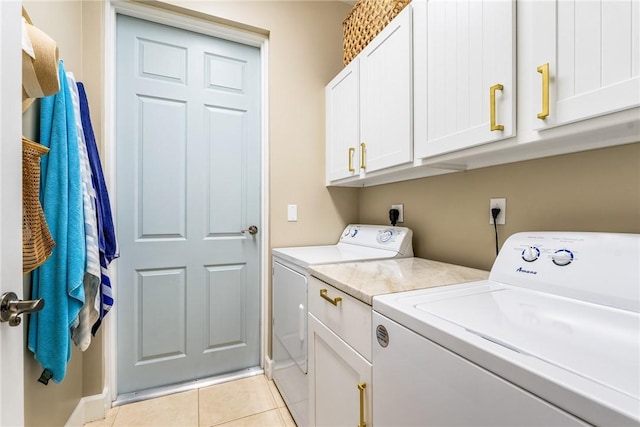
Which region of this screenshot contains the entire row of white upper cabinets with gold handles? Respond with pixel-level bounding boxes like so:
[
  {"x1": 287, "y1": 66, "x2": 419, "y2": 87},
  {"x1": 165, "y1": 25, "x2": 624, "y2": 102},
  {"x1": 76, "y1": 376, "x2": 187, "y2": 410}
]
[{"x1": 327, "y1": 0, "x2": 640, "y2": 186}]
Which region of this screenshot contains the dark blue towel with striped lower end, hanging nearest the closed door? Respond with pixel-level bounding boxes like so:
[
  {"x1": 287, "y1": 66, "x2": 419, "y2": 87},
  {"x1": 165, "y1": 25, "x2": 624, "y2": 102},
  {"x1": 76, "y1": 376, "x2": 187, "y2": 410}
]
[{"x1": 78, "y1": 83, "x2": 120, "y2": 335}]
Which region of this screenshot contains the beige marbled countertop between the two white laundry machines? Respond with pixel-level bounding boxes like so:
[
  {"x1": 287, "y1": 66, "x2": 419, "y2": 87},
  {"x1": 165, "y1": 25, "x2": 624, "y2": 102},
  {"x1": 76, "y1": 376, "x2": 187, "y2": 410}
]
[{"x1": 309, "y1": 258, "x2": 489, "y2": 305}]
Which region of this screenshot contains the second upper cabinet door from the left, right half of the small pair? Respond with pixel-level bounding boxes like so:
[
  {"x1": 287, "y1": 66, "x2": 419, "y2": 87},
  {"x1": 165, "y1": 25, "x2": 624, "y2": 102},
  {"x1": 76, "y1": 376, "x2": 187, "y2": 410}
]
[{"x1": 359, "y1": 5, "x2": 413, "y2": 172}]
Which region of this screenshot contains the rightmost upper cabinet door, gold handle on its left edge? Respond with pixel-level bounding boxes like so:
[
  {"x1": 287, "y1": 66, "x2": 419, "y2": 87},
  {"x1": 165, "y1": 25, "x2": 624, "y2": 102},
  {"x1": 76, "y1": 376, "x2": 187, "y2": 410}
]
[{"x1": 529, "y1": 0, "x2": 640, "y2": 129}]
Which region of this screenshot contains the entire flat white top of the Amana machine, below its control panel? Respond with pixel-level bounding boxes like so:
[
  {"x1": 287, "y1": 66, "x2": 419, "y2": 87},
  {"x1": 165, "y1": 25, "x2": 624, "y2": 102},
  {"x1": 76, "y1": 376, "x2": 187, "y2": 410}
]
[{"x1": 373, "y1": 280, "x2": 640, "y2": 425}]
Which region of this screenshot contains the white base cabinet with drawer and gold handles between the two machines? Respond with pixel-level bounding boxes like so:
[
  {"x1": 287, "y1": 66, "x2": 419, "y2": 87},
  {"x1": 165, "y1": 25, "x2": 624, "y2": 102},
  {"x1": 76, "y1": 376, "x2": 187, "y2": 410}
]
[{"x1": 308, "y1": 277, "x2": 373, "y2": 427}]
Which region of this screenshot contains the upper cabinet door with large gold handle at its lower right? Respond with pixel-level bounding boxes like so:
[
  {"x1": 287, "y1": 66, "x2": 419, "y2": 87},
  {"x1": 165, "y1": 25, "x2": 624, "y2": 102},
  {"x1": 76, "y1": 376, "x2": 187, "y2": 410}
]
[{"x1": 416, "y1": 0, "x2": 515, "y2": 158}]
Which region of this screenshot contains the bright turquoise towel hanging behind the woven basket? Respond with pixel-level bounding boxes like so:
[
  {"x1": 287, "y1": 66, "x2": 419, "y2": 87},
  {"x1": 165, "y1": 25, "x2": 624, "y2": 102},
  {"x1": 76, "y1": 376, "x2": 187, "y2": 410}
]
[{"x1": 28, "y1": 61, "x2": 86, "y2": 383}]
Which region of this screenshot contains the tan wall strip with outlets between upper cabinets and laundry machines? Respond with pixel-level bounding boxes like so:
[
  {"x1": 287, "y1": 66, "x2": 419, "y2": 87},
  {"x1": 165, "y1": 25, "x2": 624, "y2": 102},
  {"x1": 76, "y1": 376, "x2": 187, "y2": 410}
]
[{"x1": 360, "y1": 143, "x2": 640, "y2": 270}]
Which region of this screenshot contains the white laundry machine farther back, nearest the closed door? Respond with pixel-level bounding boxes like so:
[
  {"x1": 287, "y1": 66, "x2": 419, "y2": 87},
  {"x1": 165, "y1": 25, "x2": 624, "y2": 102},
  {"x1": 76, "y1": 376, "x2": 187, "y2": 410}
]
[{"x1": 272, "y1": 224, "x2": 413, "y2": 426}]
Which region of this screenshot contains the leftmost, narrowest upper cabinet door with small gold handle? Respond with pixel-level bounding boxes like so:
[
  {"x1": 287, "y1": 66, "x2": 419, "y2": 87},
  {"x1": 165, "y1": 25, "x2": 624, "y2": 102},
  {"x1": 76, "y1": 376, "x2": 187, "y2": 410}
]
[{"x1": 325, "y1": 58, "x2": 360, "y2": 182}]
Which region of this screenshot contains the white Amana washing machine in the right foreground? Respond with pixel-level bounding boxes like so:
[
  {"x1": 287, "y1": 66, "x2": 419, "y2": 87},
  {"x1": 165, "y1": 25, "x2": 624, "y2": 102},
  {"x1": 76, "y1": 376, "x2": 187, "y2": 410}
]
[{"x1": 373, "y1": 232, "x2": 640, "y2": 427}]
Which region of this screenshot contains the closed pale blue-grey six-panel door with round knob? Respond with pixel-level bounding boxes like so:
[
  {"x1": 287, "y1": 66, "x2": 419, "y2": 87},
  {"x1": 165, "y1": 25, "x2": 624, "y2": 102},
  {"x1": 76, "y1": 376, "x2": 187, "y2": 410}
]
[{"x1": 116, "y1": 15, "x2": 261, "y2": 394}]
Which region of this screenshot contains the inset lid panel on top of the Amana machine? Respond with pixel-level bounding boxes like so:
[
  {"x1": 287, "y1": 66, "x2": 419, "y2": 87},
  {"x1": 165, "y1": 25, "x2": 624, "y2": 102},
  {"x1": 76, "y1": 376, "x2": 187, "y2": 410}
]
[{"x1": 414, "y1": 283, "x2": 640, "y2": 399}]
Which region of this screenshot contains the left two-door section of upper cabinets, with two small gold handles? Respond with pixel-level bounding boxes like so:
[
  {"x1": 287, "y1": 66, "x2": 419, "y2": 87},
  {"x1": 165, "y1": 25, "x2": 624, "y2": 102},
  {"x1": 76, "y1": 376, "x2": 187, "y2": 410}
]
[{"x1": 325, "y1": 5, "x2": 413, "y2": 184}]
